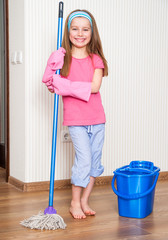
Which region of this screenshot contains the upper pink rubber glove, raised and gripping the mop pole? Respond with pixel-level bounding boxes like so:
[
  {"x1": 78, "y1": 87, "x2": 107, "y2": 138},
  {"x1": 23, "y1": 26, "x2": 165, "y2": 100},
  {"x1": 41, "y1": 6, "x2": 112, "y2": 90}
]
[{"x1": 42, "y1": 47, "x2": 66, "y2": 87}]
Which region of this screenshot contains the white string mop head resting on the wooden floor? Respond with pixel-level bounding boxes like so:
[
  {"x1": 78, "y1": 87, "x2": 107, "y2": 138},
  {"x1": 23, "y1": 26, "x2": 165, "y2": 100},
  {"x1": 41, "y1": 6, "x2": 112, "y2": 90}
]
[{"x1": 20, "y1": 212, "x2": 66, "y2": 230}]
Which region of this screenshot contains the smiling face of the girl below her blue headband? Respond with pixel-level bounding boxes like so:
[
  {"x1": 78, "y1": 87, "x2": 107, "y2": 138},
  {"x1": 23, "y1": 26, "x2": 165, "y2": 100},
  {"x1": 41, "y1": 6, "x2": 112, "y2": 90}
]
[{"x1": 69, "y1": 17, "x2": 92, "y2": 48}]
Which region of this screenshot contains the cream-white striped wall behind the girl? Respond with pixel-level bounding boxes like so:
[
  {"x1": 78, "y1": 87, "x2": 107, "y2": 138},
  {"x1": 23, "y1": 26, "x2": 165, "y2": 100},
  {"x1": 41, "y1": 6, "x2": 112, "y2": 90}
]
[{"x1": 9, "y1": 0, "x2": 168, "y2": 182}]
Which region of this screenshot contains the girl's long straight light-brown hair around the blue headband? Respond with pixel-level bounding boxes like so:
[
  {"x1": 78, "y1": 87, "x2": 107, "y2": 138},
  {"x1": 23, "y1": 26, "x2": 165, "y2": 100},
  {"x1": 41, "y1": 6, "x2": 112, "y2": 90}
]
[{"x1": 61, "y1": 9, "x2": 108, "y2": 77}]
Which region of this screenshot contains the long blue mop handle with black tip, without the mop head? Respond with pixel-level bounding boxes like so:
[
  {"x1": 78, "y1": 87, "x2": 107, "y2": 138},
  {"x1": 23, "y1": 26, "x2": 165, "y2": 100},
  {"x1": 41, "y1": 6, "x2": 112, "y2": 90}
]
[{"x1": 49, "y1": 2, "x2": 63, "y2": 207}]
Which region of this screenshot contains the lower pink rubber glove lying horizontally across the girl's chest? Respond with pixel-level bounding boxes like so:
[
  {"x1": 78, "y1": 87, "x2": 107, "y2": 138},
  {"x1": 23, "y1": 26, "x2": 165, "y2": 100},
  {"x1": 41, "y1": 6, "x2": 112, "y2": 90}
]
[{"x1": 52, "y1": 74, "x2": 91, "y2": 102}]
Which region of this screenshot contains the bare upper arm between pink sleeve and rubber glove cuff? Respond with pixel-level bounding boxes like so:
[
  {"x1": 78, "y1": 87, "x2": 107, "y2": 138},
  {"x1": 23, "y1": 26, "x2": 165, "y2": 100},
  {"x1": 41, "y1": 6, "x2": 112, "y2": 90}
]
[{"x1": 91, "y1": 68, "x2": 103, "y2": 93}]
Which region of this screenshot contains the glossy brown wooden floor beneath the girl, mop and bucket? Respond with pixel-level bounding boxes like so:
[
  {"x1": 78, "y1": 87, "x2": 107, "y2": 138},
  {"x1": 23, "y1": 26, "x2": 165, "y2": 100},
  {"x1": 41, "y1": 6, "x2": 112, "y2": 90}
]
[{"x1": 0, "y1": 181, "x2": 168, "y2": 240}]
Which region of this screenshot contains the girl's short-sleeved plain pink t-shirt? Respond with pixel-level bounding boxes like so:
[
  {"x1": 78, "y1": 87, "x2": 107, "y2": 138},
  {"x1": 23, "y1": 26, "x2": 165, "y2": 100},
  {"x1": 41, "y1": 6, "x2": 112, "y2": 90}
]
[{"x1": 62, "y1": 54, "x2": 106, "y2": 126}]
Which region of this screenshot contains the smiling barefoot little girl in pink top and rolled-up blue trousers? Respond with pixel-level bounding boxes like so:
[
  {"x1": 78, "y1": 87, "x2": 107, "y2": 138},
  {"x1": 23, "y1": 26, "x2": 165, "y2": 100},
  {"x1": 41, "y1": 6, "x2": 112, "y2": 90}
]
[{"x1": 43, "y1": 10, "x2": 108, "y2": 219}]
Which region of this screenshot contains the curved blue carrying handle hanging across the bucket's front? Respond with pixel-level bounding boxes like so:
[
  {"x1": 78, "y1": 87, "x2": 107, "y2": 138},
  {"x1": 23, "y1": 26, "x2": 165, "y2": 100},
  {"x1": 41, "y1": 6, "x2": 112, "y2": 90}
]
[{"x1": 111, "y1": 172, "x2": 159, "y2": 200}]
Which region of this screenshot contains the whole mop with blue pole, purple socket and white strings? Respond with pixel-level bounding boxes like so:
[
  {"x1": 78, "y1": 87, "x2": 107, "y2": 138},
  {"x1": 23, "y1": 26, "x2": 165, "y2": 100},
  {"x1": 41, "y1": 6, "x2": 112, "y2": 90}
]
[{"x1": 20, "y1": 2, "x2": 66, "y2": 230}]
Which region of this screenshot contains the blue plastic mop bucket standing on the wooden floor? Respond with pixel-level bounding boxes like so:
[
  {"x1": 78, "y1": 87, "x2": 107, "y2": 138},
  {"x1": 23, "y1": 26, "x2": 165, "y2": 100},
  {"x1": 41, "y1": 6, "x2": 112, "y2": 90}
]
[{"x1": 111, "y1": 161, "x2": 160, "y2": 218}]
